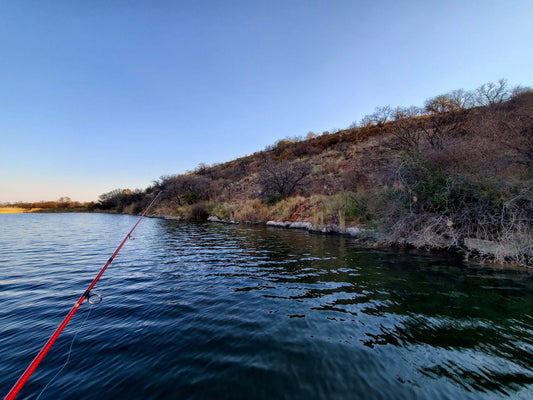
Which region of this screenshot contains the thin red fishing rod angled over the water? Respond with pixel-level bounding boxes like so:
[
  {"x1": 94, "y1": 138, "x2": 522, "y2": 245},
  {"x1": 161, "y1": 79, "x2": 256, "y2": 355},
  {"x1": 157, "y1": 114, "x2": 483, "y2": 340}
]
[{"x1": 4, "y1": 192, "x2": 162, "y2": 400}]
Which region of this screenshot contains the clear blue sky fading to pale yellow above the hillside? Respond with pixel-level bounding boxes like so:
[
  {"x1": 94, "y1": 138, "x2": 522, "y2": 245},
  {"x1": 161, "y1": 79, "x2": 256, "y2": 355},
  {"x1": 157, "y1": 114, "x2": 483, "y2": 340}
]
[{"x1": 0, "y1": 0, "x2": 533, "y2": 202}]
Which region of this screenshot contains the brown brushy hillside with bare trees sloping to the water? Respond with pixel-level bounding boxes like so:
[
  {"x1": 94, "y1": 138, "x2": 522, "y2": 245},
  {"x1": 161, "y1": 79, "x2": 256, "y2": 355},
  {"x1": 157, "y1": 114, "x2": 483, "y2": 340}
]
[{"x1": 98, "y1": 80, "x2": 533, "y2": 266}]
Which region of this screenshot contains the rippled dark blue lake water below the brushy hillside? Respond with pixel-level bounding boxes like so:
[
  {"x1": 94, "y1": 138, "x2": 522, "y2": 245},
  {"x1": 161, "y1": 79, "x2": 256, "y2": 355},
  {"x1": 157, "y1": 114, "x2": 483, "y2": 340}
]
[{"x1": 0, "y1": 214, "x2": 533, "y2": 399}]
